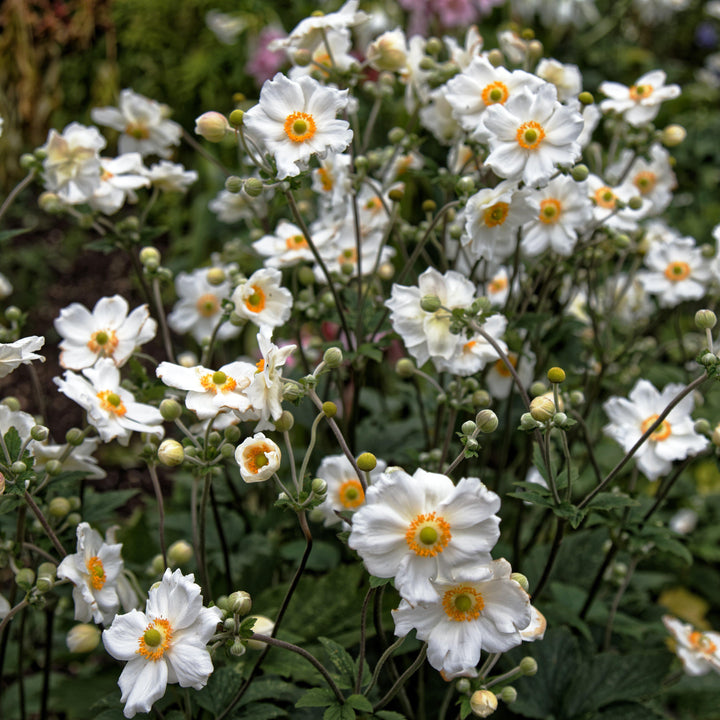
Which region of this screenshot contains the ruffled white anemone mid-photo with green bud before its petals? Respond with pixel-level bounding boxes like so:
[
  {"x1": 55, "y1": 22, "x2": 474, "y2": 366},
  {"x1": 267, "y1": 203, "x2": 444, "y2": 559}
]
[{"x1": 385, "y1": 268, "x2": 475, "y2": 365}]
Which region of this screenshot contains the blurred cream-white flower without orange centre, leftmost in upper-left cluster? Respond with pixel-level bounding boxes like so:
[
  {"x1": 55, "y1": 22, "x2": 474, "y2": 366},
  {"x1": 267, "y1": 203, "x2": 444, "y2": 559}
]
[{"x1": 41, "y1": 122, "x2": 105, "y2": 205}]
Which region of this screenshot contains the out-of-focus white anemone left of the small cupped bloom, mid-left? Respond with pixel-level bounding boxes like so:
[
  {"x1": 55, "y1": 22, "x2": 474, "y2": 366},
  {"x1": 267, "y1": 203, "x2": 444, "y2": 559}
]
[{"x1": 168, "y1": 268, "x2": 240, "y2": 343}]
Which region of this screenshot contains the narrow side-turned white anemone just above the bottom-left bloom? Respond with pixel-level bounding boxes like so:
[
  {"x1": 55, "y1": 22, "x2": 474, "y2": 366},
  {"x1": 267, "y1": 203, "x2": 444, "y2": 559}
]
[{"x1": 57, "y1": 522, "x2": 123, "y2": 625}]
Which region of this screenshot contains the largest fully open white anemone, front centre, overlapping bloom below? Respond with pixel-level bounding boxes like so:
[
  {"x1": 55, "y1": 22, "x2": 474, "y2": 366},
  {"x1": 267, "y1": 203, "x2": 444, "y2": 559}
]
[{"x1": 348, "y1": 468, "x2": 500, "y2": 603}]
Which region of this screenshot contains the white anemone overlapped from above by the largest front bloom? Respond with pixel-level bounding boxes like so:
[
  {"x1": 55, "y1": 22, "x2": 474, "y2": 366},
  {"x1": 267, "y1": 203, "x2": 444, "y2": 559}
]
[{"x1": 390, "y1": 556, "x2": 533, "y2": 676}]
